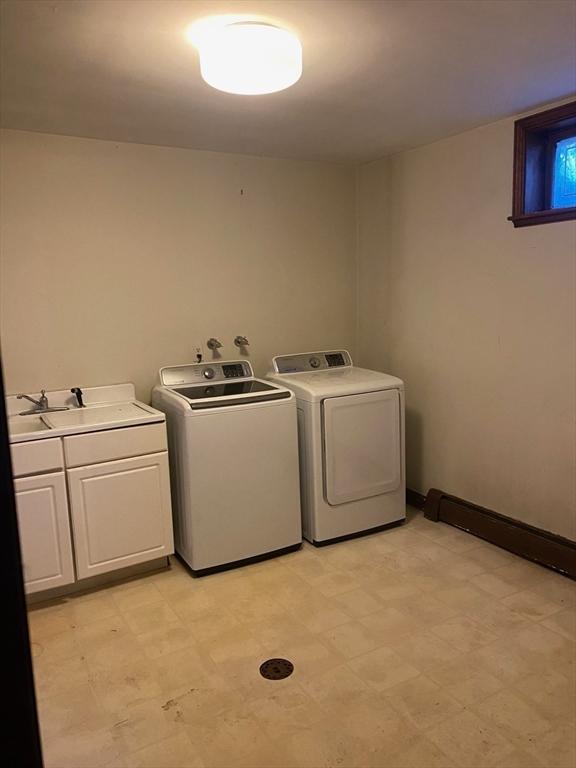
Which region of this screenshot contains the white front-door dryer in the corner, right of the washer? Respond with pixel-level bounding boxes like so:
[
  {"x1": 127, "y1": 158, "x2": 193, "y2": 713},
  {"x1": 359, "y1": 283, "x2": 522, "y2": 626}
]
[{"x1": 268, "y1": 350, "x2": 406, "y2": 545}]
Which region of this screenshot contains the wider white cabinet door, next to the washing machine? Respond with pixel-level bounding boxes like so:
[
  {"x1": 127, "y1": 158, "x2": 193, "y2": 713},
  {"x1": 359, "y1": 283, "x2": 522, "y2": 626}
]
[{"x1": 67, "y1": 451, "x2": 174, "y2": 579}]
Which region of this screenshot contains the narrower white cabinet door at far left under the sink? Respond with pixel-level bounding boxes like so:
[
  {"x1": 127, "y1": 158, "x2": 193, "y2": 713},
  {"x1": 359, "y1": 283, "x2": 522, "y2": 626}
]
[{"x1": 14, "y1": 472, "x2": 74, "y2": 594}]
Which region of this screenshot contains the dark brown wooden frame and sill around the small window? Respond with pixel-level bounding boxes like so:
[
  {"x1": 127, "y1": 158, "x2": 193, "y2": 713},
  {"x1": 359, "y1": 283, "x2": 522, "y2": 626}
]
[{"x1": 508, "y1": 101, "x2": 576, "y2": 227}]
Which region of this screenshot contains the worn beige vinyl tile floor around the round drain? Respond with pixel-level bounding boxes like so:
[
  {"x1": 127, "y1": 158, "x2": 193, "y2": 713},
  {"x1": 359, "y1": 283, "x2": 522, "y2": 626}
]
[{"x1": 29, "y1": 510, "x2": 576, "y2": 768}]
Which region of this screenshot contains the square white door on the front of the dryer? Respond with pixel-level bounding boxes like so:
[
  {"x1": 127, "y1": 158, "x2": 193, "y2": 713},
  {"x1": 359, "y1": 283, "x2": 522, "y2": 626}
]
[{"x1": 323, "y1": 389, "x2": 402, "y2": 506}]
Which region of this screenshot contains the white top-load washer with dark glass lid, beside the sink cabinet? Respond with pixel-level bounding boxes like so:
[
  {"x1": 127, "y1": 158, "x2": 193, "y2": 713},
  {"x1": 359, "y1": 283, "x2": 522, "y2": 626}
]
[{"x1": 152, "y1": 360, "x2": 302, "y2": 575}]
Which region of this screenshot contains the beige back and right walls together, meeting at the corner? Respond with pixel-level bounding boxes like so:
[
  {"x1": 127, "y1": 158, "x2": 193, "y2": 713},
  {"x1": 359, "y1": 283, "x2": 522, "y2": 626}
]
[{"x1": 0, "y1": 120, "x2": 576, "y2": 539}]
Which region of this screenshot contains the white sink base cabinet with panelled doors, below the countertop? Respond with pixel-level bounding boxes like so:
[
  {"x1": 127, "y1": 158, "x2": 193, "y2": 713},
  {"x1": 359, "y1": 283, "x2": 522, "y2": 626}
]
[{"x1": 11, "y1": 414, "x2": 174, "y2": 593}]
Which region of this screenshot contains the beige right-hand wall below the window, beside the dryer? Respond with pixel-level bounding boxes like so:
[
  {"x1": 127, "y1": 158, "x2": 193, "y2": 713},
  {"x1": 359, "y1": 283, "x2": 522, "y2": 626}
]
[{"x1": 358, "y1": 114, "x2": 576, "y2": 539}]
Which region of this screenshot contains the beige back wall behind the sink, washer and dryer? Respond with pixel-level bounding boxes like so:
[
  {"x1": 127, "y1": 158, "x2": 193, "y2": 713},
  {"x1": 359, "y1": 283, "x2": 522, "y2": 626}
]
[{"x1": 0, "y1": 131, "x2": 356, "y2": 399}]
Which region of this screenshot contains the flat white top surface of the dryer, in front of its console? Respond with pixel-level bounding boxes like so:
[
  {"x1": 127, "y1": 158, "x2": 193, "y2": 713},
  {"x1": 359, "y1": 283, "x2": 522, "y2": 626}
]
[{"x1": 270, "y1": 366, "x2": 404, "y2": 402}]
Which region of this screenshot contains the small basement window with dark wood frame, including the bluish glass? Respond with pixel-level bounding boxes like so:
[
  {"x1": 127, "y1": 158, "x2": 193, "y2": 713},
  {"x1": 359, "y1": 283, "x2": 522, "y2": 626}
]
[{"x1": 509, "y1": 101, "x2": 576, "y2": 227}]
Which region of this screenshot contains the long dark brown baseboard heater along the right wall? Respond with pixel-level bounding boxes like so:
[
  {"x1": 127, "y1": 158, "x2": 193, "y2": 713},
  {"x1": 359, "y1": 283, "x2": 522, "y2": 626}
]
[{"x1": 424, "y1": 488, "x2": 576, "y2": 579}]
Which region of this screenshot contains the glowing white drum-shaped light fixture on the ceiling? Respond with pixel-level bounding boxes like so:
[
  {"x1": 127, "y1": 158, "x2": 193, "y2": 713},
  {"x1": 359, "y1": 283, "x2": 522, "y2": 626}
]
[{"x1": 188, "y1": 21, "x2": 302, "y2": 95}]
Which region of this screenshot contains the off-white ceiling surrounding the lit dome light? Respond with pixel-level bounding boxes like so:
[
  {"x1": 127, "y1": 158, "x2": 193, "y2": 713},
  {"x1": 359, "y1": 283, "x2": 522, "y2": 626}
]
[{"x1": 1, "y1": 0, "x2": 576, "y2": 162}]
